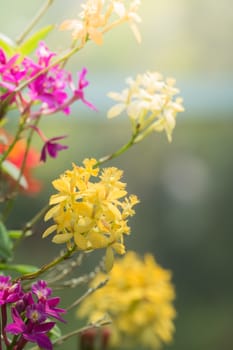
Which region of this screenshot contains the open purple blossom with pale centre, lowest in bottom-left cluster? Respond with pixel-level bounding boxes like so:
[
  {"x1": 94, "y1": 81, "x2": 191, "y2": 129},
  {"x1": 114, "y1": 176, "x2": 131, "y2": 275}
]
[{"x1": 5, "y1": 305, "x2": 55, "y2": 350}]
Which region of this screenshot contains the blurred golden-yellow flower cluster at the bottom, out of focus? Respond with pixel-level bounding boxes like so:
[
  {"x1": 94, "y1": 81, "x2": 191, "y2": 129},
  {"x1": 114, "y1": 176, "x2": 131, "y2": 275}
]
[{"x1": 77, "y1": 252, "x2": 176, "y2": 349}]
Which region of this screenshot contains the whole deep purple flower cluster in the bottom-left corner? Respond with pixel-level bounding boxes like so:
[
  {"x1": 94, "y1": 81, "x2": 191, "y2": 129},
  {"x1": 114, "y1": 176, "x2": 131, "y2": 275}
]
[{"x1": 0, "y1": 275, "x2": 65, "y2": 350}]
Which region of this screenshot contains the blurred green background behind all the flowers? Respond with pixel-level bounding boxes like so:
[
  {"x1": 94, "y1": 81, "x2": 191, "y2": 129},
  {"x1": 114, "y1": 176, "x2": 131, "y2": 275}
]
[{"x1": 0, "y1": 0, "x2": 233, "y2": 350}]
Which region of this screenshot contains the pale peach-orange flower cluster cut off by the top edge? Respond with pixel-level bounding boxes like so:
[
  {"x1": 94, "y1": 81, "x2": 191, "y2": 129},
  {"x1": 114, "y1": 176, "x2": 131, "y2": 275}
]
[{"x1": 60, "y1": 0, "x2": 141, "y2": 46}]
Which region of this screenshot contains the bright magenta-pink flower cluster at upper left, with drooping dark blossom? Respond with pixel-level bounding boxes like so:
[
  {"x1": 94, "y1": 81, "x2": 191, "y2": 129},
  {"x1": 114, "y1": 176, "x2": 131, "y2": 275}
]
[{"x1": 0, "y1": 42, "x2": 95, "y2": 161}]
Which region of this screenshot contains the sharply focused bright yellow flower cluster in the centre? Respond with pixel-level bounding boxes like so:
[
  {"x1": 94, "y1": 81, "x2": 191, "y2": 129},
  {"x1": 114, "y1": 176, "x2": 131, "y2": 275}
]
[{"x1": 43, "y1": 159, "x2": 138, "y2": 269}]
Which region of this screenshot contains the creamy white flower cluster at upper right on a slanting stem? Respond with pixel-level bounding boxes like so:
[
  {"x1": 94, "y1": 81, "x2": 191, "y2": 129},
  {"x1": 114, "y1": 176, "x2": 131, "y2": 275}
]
[{"x1": 108, "y1": 72, "x2": 184, "y2": 143}]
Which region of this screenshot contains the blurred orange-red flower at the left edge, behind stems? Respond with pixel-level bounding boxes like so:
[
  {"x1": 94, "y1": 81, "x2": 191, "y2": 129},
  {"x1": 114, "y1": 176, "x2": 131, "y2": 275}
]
[{"x1": 0, "y1": 129, "x2": 41, "y2": 194}]
